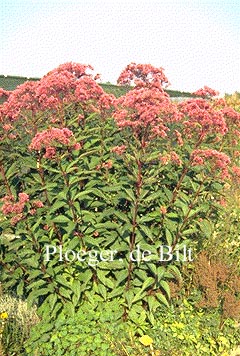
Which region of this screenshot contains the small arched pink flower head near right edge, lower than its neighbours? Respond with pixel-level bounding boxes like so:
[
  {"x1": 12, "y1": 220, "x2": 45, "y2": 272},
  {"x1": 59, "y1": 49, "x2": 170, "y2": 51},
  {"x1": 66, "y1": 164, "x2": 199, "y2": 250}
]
[{"x1": 191, "y1": 149, "x2": 231, "y2": 179}]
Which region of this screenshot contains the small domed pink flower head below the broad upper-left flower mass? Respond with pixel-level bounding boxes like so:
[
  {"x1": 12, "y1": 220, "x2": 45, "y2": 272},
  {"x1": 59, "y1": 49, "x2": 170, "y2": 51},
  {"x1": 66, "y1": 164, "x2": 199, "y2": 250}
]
[{"x1": 29, "y1": 127, "x2": 81, "y2": 159}]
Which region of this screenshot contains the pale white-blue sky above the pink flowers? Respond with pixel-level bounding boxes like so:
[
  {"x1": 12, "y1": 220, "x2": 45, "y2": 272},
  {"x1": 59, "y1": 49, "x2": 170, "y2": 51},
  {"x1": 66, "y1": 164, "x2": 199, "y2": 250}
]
[{"x1": 0, "y1": 0, "x2": 240, "y2": 94}]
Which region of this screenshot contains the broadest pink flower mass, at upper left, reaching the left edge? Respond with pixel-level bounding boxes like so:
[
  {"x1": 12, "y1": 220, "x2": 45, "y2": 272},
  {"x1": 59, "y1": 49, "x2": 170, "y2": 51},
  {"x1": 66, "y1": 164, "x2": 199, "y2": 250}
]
[{"x1": 0, "y1": 62, "x2": 113, "y2": 126}]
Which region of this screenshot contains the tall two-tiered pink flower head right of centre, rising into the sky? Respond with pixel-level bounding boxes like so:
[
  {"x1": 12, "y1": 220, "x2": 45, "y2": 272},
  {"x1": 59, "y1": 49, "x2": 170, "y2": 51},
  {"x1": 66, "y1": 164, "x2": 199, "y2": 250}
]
[{"x1": 113, "y1": 63, "x2": 182, "y2": 147}]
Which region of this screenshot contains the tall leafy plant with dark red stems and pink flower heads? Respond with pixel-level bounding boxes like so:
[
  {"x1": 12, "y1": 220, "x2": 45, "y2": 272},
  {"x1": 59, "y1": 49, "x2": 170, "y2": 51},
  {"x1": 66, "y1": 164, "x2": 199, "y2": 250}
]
[{"x1": 0, "y1": 63, "x2": 240, "y2": 355}]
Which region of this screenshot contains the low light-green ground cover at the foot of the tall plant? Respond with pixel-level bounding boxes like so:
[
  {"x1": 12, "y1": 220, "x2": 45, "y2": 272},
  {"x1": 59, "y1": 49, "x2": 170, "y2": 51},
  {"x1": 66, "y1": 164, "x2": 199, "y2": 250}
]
[{"x1": 22, "y1": 300, "x2": 240, "y2": 356}]
